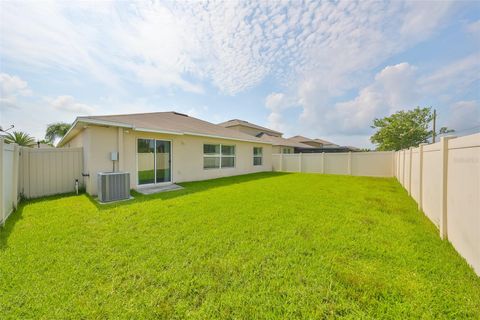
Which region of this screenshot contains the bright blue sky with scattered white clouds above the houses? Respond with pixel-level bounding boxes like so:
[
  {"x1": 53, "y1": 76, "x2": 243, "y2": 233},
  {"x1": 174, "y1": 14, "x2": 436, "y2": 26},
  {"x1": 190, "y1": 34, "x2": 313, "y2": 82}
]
[{"x1": 0, "y1": 1, "x2": 480, "y2": 147}]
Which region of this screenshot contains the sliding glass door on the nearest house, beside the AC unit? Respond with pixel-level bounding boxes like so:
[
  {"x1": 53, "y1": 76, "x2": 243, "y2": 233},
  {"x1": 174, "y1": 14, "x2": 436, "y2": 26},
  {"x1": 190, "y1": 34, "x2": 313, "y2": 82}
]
[{"x1": 137, "y1": 139, "x2": 172, "y2": 184}]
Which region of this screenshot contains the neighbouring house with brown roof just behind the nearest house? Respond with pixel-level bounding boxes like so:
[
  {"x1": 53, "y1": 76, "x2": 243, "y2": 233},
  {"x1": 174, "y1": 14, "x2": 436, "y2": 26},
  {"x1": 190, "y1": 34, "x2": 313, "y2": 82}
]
[{"x1": 218, "y1": 119, "x2": 311, "y2": 154}]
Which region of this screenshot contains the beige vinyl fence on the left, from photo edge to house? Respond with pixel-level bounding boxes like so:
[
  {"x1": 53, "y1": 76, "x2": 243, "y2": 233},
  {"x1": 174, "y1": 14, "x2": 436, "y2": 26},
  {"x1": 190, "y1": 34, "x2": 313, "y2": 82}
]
[{"x1": 0, "y1": 137, "x2": 83, "y2": 225}]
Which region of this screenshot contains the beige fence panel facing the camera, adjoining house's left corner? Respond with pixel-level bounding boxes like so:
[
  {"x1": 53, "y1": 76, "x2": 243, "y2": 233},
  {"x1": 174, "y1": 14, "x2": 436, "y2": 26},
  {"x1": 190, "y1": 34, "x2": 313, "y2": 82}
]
[{"x1": 19, "y1": 148, "x2": 83, "y2": 198}]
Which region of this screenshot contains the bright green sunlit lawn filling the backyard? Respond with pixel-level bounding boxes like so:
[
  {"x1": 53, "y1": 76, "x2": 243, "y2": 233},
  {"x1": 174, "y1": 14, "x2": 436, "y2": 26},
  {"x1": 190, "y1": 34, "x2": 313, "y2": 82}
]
[{"x1": 0, "y1": 173, "x2": 480, "y2": 319}]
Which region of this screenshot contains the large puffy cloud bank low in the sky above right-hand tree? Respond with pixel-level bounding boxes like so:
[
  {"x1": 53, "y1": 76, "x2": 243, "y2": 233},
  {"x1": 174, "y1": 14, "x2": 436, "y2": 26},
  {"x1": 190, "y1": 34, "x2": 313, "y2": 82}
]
[{"x1": 275, "y1": 50, "x2": 480, "y2": 139}]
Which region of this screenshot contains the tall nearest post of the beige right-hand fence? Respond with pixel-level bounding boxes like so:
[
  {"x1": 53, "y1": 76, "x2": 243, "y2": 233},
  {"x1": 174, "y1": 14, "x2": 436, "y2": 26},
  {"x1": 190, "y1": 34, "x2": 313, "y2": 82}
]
[{"x1": 440, "y1": 136, "x2": 456, "y2": 239}]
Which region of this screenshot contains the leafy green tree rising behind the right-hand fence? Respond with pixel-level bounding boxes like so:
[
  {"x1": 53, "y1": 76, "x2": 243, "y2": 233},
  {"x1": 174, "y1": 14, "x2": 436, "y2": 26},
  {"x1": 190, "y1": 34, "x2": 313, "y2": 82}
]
[{"x1": 370, "y1": 107, "x2": 453, "y2": 151}]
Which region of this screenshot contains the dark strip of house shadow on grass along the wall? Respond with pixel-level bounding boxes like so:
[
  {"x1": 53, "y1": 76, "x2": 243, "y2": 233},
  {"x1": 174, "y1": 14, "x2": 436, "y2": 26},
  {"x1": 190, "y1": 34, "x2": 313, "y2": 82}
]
[{"x1": 88, "y1": 172, "x2": 290, "y2": 210}]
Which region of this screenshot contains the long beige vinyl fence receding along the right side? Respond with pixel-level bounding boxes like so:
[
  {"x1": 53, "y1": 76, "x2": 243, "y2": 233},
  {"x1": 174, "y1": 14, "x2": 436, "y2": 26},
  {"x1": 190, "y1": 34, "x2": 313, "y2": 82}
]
[{"x1": 395, "y1": 133, "x2": 480, "y2": 275}]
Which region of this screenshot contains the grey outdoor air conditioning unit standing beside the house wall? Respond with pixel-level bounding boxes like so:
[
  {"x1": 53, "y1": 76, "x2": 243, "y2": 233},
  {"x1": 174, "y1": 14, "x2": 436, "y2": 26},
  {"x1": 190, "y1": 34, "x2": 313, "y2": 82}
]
[{"x1": 98, "y1": 172, "x2": 130, "y2": 202}]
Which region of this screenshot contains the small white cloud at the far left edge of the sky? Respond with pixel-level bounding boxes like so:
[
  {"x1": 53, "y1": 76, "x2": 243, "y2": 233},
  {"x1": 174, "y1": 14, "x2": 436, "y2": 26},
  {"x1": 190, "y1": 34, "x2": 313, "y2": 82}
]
[{"x1": 0, "y1": 73, "x2": 31, "y2": 108}]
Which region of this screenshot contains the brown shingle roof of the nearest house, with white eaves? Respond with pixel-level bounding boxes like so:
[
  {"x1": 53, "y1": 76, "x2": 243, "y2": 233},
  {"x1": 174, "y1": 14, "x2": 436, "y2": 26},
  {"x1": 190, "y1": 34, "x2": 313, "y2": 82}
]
[{"x1": 58, "y1": 112, "x2": 270, "y2": 146}]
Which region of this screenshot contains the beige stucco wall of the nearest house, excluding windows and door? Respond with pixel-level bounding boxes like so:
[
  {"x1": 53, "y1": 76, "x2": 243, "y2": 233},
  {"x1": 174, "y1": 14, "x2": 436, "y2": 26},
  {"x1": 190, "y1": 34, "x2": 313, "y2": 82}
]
[{"x1": 65, "y1": 126, "x2": 272, "y2": 195}]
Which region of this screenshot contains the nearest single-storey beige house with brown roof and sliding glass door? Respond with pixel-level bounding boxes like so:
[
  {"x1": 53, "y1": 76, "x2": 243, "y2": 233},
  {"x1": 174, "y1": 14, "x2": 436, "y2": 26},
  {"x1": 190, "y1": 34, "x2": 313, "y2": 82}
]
[{"x1": 58, "y1": 112, "x2": 272, "y2": 195}]
